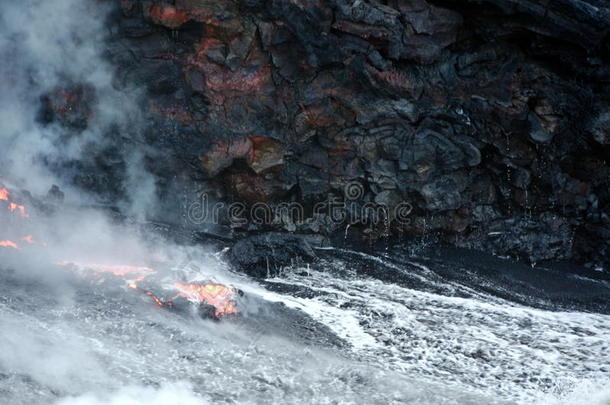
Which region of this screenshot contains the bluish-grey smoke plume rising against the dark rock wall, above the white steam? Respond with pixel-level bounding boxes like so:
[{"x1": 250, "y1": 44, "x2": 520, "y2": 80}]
[{"x1": 0, "y1": 0, "x2": 156, "y2": 219}]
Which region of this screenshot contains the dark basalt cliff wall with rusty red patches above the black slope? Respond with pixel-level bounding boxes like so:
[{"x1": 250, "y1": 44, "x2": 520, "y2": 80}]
[{"x1": 46, "y1": 0, "x2": 610, "y2": 264}]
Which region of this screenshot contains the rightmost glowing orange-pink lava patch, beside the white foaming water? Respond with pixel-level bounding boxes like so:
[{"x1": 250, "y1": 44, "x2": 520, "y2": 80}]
[{"x1": 174, "y1": 283, "x2": 237, "y2": 318}]
